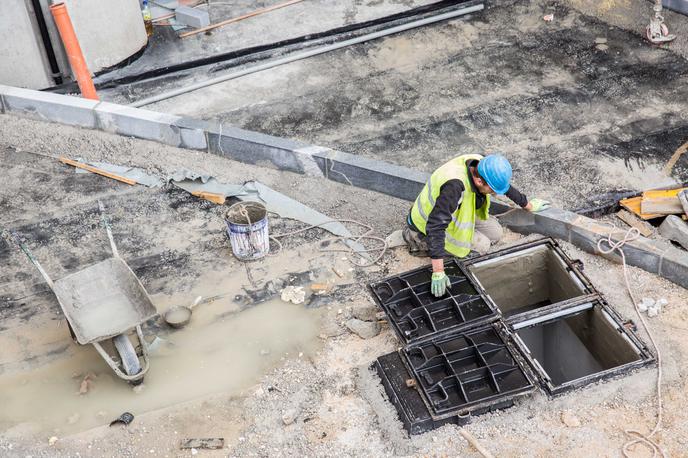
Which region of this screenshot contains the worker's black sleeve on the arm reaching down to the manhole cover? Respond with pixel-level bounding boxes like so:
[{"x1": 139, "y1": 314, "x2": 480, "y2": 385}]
[{"x1": 425, "y1": 180, "x2": 464, "y2": 259}]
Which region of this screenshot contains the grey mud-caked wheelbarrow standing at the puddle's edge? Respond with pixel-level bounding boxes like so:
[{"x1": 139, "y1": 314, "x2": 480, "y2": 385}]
[{"x1": 3, "y1": 202, "x2": 157, "y2": 385}]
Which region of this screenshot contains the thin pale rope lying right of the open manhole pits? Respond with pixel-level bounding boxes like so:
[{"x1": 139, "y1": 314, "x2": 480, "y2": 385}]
[{"x1": 597, "y1": 227, "x2": 666, "y2": 458}]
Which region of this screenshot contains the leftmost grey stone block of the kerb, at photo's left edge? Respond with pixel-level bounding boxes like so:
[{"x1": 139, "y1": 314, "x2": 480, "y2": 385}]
[{"x1": 0, "y1": 85, "x2": 100, "y2": 129}]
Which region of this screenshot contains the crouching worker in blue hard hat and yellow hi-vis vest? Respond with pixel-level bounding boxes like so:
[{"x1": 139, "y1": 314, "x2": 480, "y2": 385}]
[{"x1": 403, "y1": 154, "x2": 549, "y2": 297}]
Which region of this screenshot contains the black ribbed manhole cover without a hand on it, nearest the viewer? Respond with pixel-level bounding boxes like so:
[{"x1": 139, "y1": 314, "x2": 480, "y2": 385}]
[{"x1": 403, "y1": 327, "x2": 532, "y2": 416}]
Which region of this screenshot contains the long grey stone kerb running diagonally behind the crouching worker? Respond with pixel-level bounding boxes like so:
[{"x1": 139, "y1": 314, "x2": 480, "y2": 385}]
[{"x1": 0, "y1": 85, "x2": 688, "y2": 288}]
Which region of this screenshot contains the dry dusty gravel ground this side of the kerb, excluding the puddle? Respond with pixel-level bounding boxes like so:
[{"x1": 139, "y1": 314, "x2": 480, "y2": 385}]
[{"x1": 0, "y1": 116, "x2": 688, "y2": 457}]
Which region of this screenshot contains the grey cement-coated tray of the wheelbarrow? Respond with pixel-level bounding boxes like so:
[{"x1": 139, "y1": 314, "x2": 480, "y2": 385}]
[{"x1": 54, "y1": 257, "x2": 157, "y2": 345}]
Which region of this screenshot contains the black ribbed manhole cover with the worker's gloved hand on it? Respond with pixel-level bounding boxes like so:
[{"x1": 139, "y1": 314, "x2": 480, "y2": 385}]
[{"x1": 371, "y1": 261, "x2": 496, "y2": 343}]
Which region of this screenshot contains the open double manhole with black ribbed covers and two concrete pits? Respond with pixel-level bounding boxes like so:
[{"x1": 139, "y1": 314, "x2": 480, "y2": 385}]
[{"x1": 370, "y1": 238, "x2": 654, "y2": 434}]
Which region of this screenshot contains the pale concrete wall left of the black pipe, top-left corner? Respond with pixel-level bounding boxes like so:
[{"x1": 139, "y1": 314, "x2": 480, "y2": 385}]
[{"x1": 0, "y1": 0, "x2": 53, "y2": 89}]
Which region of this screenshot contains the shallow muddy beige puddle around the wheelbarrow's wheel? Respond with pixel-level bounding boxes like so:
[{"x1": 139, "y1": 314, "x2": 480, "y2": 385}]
[{"x1": 0, "y1": 299, "x2": 320, "y2": 437}]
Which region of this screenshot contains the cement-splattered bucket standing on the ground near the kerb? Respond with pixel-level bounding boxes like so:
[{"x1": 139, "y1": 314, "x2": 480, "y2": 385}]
[{"x1": 225, "y1": 202, "x2": 270, "y2": 261}]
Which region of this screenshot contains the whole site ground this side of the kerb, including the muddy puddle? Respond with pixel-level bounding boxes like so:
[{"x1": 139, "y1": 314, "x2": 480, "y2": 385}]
[{"x1": 0, "y1": 115, "x2": 688, "y2": 457}]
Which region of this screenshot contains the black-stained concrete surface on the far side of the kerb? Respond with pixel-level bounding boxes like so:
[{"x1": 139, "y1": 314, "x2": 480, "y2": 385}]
[{"x1": 123, "y1": 0, "x2": 688, "y2": 209}]
